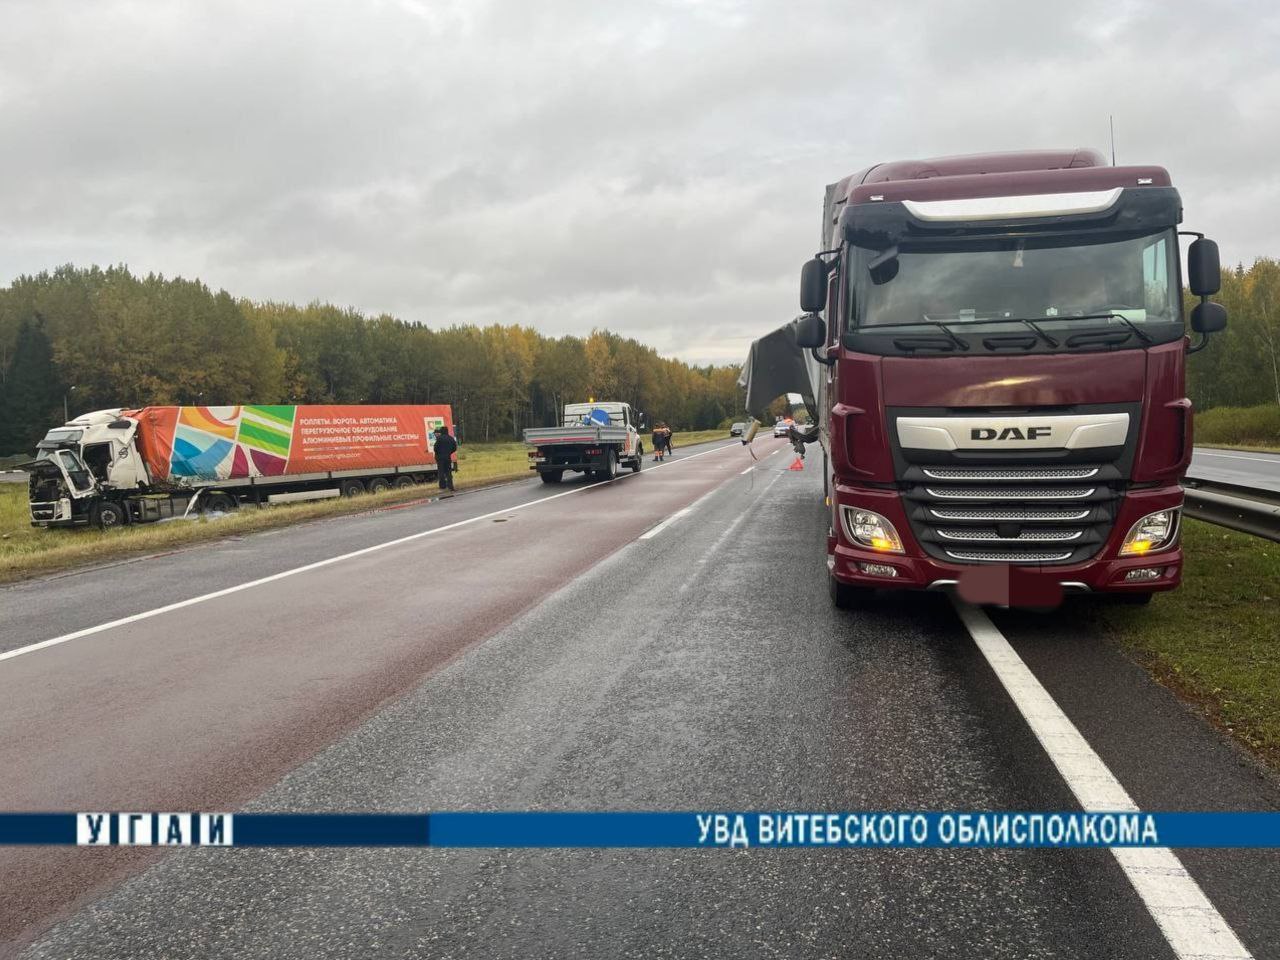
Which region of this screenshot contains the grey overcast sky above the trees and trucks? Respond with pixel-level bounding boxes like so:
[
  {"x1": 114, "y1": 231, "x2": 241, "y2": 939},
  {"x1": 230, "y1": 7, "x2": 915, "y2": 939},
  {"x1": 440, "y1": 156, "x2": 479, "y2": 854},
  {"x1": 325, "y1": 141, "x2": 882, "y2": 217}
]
[{"x1": 0, "y1": 0, "x2": 1280, "y2": 362}]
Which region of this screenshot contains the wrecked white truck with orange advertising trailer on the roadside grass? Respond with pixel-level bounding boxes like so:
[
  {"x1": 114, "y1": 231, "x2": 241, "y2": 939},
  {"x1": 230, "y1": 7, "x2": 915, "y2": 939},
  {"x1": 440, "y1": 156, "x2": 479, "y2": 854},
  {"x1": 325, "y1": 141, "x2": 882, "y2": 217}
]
[{"x1": 31, "y1": 404, "x2": 453, "y2": 526}]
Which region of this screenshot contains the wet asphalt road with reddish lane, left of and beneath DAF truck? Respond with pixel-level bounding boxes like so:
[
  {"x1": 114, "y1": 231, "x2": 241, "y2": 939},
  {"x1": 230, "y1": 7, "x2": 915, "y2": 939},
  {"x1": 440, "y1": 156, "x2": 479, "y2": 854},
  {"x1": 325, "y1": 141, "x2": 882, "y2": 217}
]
[{"x1": 0, "y1": 442, "x2": 1280, "y2": 957}]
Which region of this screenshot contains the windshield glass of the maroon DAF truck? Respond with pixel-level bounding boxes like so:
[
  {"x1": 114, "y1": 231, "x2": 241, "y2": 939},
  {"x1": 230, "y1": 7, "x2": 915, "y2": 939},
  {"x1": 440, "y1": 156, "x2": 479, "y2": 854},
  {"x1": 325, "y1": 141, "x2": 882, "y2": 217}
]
[{"x1": 850, "y1": 230, "x2": 1181, "y2": 333}]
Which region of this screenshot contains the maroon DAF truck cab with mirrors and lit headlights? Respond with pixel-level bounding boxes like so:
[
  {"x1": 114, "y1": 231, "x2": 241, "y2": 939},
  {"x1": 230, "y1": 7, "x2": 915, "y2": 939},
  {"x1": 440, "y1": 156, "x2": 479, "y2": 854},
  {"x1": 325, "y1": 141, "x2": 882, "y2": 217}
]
[{"x1": 795, "y1": 151, "x2": 1226, "y2": 607}]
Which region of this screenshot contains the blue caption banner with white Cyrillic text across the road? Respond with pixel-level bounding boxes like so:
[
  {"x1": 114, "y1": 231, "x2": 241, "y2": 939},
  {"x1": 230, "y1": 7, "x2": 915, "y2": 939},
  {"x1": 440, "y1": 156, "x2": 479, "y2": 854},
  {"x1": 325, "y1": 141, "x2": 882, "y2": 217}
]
[{"x1": 0, "y1": 810, "x2": 1280, "y2": 849}]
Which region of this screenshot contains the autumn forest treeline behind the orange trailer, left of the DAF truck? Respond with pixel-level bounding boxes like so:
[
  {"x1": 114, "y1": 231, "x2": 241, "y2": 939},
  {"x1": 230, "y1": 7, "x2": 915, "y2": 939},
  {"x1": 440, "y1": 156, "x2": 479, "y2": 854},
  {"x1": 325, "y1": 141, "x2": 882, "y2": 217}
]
[{"x1": 0, "y1": 266, "x2": 742, "y2": 454}]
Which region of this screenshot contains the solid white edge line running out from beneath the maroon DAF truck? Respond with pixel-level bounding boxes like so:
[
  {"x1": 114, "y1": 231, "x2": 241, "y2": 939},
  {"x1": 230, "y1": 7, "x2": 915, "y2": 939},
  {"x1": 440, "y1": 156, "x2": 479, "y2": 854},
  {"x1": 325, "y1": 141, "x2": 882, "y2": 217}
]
[{"x1": 952, "y1": 600, "x2": 1252, "y2": 960}]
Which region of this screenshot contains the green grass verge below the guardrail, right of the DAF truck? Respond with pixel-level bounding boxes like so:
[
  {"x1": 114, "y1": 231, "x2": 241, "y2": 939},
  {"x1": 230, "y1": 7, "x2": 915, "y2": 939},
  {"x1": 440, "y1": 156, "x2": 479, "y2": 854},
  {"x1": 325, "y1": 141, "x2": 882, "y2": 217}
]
[{"x1": 1088, "y1": 520, "x2": 1280, "y2": 768}]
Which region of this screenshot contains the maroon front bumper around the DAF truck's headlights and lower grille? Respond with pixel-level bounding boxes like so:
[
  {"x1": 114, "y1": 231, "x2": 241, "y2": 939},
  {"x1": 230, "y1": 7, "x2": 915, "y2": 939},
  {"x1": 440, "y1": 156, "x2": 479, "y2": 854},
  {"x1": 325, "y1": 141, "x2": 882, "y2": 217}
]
[{"x1": 827, "y1": 484, "x2": 1183, "y2": 603}]
